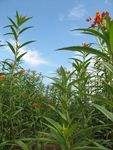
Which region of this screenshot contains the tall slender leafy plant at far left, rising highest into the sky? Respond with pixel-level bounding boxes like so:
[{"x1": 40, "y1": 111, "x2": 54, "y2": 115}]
[{"x1": 0, "y1": 12, "x2": 34, "y2": 149}]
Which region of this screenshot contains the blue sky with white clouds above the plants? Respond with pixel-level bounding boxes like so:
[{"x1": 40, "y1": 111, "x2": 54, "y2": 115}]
[{"x1": 0, "y1": 0, "x2": 113, "y2": 82}]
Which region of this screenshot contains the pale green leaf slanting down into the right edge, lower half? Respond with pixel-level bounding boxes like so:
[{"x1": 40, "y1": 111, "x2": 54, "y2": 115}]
[{"x1": 93, "y1": 104, "x2": 113, "y2": 121}]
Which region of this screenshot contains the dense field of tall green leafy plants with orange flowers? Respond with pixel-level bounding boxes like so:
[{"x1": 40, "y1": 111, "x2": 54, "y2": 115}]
[{"x1": 0, "y1": 11, "x2": 113, "y2": 150}]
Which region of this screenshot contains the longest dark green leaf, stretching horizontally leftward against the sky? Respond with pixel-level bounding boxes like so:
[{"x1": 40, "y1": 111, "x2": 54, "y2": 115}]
[{"x1": 58, "y1": 46, "x2": 110, "y2": 60}]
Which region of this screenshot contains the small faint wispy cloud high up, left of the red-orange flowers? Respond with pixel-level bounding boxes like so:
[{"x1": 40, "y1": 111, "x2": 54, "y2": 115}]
[{"x1": 68, "y1": 4, "x2": 87, "y2": 19}]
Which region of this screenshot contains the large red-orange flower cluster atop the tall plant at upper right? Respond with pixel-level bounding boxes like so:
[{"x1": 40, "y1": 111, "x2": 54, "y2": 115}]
[{"x1": 86, "y1": 11, "x2": 110, "y2": 29}]
